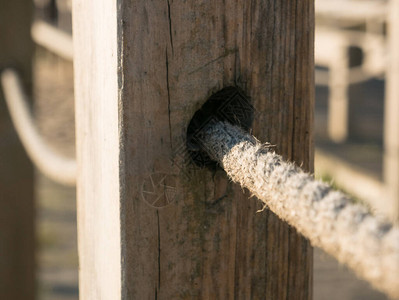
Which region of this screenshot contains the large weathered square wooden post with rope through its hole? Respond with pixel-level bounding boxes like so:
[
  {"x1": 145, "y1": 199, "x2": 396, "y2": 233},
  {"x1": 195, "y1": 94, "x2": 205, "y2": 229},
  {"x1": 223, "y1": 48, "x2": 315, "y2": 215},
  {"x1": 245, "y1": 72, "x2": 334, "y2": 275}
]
[{"x1": 73, "y1": 0, "x2": 314, "y2": 299}]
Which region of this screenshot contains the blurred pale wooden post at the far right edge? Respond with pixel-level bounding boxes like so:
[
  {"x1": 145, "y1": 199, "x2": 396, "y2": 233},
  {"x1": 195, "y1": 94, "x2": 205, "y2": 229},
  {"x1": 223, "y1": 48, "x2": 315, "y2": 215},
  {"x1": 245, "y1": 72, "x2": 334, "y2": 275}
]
[{"x1": 384, "y1": 0, "x2": 399, "y2": 218}]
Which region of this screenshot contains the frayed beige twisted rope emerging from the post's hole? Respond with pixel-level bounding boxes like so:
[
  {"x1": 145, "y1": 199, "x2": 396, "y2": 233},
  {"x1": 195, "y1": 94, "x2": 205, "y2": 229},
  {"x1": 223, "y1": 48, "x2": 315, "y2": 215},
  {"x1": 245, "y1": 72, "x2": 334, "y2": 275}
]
[{"x1": 199, "y1": 122, "x2": 399, "y2": 299}]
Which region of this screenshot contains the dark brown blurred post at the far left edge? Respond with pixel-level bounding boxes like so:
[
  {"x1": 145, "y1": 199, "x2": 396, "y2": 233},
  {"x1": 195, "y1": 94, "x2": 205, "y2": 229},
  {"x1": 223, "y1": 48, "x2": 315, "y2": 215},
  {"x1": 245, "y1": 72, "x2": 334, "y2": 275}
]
[{"x1": 0, "y1": 0, "x2": 35, "y2": 299}]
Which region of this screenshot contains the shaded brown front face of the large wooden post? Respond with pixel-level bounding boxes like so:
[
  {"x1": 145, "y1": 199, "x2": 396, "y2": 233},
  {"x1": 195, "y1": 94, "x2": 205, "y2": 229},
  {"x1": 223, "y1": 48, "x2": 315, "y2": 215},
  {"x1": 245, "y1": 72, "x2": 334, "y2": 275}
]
[{"x1": 119, "y1": 0, "x2": 313, "y2": 299}]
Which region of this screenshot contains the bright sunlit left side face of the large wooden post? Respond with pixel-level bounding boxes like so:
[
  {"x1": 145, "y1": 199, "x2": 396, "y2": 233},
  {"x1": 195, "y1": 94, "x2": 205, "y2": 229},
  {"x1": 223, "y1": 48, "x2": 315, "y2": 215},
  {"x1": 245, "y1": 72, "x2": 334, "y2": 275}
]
[{"x1": 73, "y1": 0, "x2": 124, "y2": 299}]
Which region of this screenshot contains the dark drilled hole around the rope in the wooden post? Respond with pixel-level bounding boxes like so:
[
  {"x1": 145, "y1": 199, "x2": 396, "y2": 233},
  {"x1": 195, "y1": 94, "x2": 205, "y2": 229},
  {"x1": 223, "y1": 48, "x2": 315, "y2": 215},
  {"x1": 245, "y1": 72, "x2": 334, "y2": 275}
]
[{"x1": 186, "y1": 86, "x2": 255, "y2": 169}]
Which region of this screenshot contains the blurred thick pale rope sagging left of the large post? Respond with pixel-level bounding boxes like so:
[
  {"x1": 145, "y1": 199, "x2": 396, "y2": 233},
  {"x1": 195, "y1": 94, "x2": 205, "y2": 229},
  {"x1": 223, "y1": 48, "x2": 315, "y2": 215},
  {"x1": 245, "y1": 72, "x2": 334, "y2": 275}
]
[{"x1": 1, "y1": 69, "x2": 77, "y2": 186}]
